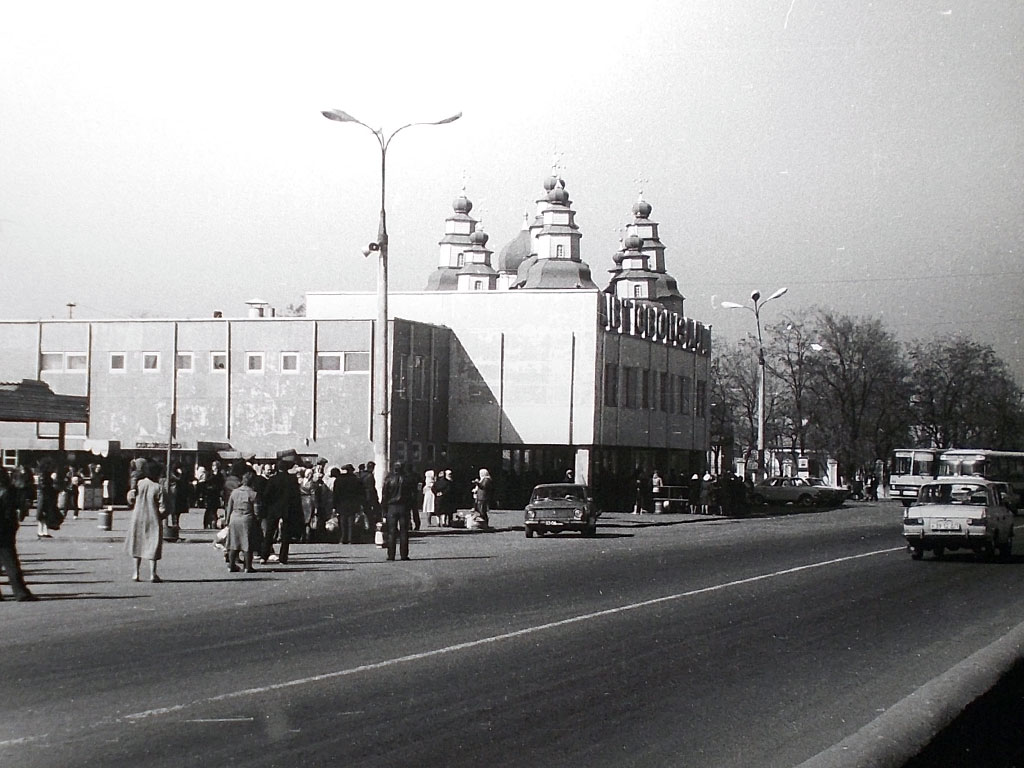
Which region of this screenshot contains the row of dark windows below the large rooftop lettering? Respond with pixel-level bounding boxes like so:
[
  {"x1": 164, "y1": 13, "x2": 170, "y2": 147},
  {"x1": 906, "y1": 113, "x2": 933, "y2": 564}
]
[{"x1": 604, "y1": 364, "x2": 708, "y2": 416}]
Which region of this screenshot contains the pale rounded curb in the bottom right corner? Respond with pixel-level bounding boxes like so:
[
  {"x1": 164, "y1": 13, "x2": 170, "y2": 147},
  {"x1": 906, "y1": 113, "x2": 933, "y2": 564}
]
[{"x1": 797, "y1": 623, "x2": 1024, "y2": 768}]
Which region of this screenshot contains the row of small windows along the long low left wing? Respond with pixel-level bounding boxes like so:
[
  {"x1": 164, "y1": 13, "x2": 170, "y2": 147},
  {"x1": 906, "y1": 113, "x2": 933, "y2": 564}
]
[{"x1": 39, "y1": 352, "x2": 370, "y2": 374}]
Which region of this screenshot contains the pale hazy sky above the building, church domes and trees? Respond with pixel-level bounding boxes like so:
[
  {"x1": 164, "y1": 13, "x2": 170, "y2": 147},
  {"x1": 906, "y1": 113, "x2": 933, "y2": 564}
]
[{"x1": 0, "y1": 0, "x2": 1024, "y2": 384}]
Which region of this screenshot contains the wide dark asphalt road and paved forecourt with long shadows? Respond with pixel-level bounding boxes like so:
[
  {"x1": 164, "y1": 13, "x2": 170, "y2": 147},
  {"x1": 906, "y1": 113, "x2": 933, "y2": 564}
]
[{"x1": 6, "y1": 503, "x2": 1024, "y2": 768}]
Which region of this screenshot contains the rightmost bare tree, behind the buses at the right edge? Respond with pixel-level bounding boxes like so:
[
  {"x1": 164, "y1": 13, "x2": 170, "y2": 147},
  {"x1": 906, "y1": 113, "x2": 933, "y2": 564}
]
[{"x1": 908, "y1": 335, "x2": 1024, "y2": 451}]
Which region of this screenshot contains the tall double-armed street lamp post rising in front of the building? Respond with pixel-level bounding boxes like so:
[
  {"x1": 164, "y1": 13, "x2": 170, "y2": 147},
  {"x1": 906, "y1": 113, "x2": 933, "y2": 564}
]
[{"x1": 321, "y1": 110, "x2": 462, "y2": 487}]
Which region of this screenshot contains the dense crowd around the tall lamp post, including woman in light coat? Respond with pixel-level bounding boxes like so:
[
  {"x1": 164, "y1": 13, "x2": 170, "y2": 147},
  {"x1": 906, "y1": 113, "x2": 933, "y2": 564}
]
[{"x1": 126, "y1": 456, "x2": 493, "y2": 582}]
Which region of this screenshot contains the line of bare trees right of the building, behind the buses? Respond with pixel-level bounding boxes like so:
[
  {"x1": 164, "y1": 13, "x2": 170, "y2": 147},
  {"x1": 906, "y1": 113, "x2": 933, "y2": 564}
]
[{"x1": 711, "y1": 307, "x2": 1024, "y2": 477}]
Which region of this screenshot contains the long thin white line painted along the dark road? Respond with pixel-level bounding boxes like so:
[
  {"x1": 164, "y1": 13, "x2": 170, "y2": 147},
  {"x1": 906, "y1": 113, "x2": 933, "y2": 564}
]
[{"x1": 119, "y1": 547, "x2": 906, "y2": 724}]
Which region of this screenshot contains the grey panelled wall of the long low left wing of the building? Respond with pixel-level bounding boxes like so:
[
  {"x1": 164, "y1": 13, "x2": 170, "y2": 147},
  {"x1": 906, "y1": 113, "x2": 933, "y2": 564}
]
[{"x1": 0, "y1": 318, "x2": 450, "y2": 463}]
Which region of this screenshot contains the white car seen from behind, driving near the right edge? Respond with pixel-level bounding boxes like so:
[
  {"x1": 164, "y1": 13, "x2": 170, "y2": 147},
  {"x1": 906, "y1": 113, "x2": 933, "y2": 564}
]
[{"x1": 903, "y1": 477, "x2": 1014, "y2": 560}]
